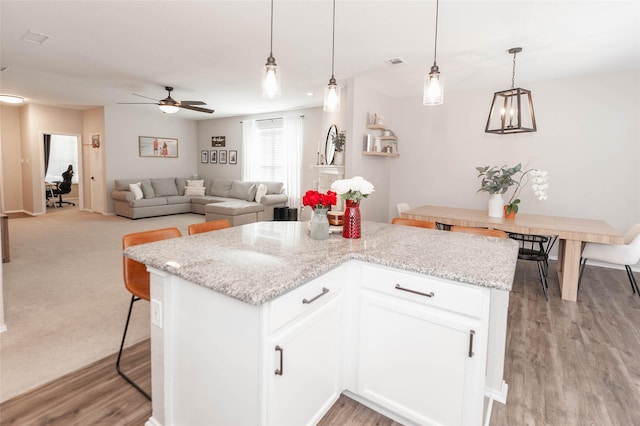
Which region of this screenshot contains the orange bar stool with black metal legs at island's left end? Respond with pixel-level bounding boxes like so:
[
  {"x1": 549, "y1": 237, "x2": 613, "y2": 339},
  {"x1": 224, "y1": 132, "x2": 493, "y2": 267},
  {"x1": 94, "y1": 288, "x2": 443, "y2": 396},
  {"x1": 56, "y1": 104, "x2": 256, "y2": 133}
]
[{"x1": 116, "y1": 228, "x2": 182, "y2": 401}]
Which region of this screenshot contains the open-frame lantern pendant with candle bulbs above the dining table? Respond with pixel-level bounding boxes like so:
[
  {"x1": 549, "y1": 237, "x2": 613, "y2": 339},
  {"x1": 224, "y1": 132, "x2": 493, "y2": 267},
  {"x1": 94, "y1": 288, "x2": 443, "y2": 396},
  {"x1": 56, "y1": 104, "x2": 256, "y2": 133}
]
[{"x1": 484, "y1": 47, "x2": 537, "y2": 135}]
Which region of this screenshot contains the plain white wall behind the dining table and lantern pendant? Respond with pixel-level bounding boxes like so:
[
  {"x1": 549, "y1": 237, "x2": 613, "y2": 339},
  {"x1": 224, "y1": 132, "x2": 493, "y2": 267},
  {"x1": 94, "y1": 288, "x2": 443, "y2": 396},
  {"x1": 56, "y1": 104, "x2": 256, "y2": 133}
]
[{"x1": 387, "y1": 71, "x2": 640, "y2": 232}]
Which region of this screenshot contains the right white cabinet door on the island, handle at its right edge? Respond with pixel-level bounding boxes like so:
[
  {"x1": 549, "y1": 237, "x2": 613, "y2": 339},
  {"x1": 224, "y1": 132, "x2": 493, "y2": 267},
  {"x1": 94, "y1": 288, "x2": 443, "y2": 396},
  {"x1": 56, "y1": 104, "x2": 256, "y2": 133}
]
[{"x1": 358, "y1": 290, "x2": 484, "y2": 425}]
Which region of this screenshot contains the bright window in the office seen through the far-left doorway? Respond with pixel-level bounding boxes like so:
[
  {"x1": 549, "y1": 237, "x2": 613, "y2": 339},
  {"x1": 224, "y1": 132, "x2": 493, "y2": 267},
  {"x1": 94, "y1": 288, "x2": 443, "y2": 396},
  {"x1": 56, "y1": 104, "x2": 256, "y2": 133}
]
[{"x1": 44, "y1": 135, "x2": 78, "y2": 183}]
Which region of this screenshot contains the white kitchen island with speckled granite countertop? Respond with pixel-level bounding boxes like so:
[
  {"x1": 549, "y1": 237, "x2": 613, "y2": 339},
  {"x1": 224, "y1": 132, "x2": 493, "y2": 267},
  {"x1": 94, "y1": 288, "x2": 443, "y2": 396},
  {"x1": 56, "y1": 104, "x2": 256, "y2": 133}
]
[{"x1": 125, "y1": 222, "x2": 518, "y2": 426}]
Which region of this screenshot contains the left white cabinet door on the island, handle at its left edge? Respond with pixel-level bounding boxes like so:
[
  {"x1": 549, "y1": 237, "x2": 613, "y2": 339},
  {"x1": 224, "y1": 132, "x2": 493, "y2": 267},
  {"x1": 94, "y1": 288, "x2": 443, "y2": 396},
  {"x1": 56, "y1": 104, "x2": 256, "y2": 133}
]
[{"x1": 267, "y1": 296, "x2": 342, "y2": 426}]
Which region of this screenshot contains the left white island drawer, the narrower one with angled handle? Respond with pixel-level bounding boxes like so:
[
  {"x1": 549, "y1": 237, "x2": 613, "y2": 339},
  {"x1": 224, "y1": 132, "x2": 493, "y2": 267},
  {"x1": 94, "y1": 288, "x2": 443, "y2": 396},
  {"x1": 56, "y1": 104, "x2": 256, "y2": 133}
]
[{"x1": 269, "y1": 268, "x2": 342, "y2": 332}]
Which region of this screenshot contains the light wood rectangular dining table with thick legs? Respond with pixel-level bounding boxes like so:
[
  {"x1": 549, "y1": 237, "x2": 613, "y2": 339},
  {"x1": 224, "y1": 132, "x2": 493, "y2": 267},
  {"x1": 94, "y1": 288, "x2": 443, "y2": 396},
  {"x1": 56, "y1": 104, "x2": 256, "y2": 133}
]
[{"x1": 401, "y1": 206, "x2": 624, "y2": 302}]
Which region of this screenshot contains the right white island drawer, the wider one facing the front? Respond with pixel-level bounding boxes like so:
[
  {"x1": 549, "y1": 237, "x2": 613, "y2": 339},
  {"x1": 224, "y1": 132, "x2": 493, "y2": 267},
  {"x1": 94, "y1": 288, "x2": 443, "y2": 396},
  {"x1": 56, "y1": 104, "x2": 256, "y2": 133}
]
[{"x1": 362, "y1": 265, "x2": 489, "y2": 318}]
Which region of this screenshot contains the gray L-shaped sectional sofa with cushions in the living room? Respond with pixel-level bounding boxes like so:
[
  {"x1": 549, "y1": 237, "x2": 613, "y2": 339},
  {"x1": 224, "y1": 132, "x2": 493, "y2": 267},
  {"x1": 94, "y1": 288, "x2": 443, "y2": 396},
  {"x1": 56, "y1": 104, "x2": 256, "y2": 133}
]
[{"x1": 111, "y1": 178, "x2": 287, "y2": 225}]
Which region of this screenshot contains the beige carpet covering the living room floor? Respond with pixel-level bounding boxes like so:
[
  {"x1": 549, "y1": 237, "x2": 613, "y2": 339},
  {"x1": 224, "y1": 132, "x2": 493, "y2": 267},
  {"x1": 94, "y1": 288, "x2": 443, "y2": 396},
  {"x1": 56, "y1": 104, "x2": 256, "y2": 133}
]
[{"x1": 0, "y1": 207, "x2": 204, "y2": 401}]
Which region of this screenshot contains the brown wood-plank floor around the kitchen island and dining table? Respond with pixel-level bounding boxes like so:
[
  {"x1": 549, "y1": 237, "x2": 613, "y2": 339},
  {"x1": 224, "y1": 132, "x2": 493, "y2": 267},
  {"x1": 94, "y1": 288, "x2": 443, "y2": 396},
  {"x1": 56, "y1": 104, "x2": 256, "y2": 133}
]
[{"x1": 0, "y1": 262, "x2": 640, "y2": 426}]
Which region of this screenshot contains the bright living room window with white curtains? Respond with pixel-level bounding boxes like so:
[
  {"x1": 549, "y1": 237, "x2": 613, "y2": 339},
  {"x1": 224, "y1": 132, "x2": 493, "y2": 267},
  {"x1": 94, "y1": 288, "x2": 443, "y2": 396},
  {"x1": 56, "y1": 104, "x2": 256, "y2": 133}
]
[{"x1": 242, "y1": 117, "x2": 303, "y2": 207}]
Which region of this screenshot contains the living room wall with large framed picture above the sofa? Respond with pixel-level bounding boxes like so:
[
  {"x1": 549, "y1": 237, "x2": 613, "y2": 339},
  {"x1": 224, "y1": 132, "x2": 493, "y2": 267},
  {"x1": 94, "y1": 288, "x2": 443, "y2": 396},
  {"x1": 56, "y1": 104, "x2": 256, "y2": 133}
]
[{"x1": 102, "y1": 105, "x2": 200, "y2": 212}]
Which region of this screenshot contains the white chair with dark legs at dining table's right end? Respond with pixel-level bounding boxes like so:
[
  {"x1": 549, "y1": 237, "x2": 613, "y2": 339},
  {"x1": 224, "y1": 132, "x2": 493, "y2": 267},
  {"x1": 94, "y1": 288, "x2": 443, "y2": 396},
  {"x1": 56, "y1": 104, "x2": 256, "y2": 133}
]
[{"x1": 578, "y1": 223, "x2": 640, "y2": 296}]
